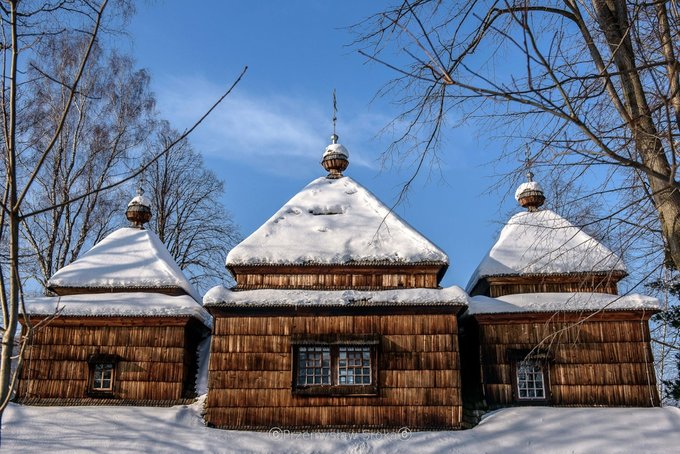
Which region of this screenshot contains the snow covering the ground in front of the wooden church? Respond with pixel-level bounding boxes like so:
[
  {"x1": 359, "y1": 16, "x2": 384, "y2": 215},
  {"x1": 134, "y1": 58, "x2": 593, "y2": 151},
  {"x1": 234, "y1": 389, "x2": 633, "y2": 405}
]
[{"x1": 2, "y1": 400, "x2": 680, "y2": 454}]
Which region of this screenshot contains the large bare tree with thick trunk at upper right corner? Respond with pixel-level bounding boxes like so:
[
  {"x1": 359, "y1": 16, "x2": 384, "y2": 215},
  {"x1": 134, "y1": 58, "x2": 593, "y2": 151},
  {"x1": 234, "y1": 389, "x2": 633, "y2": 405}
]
[{"x1": 358, "y1": 0, "x2": 680, "y2": 274}]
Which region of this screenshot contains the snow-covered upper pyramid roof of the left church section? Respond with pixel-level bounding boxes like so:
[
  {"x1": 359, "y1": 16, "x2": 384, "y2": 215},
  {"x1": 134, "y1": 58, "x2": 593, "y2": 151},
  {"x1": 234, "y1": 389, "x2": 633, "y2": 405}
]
[{"x1": 47, "y1": 228, "x2": 200, "y2": 301}]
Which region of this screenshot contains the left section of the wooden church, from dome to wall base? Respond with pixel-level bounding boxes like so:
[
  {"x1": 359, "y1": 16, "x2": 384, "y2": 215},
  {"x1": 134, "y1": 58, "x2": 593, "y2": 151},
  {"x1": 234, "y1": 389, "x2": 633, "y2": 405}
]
[{"x1": 16, "y1": 194, "x2": 211, "y2": 406}]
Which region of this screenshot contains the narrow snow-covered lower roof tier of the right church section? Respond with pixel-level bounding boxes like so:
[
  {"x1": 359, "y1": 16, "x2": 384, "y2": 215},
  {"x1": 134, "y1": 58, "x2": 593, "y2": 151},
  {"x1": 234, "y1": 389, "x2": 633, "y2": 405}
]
[{"x1": 468, "y1": 293, "x2": 660, "y2": 314}]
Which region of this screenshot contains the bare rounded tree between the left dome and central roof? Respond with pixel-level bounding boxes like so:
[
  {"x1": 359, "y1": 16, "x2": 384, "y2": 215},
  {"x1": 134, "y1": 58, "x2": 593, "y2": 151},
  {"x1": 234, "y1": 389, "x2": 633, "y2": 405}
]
[{"x1": 143, "y1": 122, "x2": 239, "y2": 291}]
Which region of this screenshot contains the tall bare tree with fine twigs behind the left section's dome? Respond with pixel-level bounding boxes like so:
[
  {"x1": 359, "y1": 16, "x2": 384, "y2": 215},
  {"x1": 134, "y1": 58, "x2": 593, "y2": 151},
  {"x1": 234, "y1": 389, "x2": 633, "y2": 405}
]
[{"x1": 21, "y1": 32, "x2": 155, "y2": 287}]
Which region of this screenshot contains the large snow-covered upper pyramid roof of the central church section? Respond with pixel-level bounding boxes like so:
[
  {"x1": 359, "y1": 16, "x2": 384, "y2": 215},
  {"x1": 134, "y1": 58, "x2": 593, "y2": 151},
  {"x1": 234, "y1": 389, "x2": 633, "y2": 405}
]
[{"x1": 227, "y1": 177, "x2": 448, "y2": 266}]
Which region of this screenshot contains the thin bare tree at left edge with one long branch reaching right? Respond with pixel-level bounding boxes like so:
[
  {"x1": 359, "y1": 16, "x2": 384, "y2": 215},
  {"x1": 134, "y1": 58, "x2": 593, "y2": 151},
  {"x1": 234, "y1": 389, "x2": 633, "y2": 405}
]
[{"x1": 0, "y1": 0, "x2": 247, "y2": 432}]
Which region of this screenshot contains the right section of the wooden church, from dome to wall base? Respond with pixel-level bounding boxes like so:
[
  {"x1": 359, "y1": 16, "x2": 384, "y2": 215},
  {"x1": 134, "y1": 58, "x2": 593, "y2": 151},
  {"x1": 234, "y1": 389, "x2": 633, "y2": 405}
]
[{"x1": 462, "y1": 173, "x2": 659, "y2": 409}]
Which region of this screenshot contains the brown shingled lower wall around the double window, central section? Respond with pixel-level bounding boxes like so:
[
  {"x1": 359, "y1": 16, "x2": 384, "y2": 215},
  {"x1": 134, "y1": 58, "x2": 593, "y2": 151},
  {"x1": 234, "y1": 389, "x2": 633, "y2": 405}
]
[{"x1": 206, "y1": 314, "x2": 462, "y2": 430}]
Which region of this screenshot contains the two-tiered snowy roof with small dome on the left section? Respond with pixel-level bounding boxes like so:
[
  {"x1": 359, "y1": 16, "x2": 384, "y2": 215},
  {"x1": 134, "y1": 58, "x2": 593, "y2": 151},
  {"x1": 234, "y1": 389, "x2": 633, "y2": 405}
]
[{"x1": 39, "y1": 190, "x2": 211, "y2": 327}]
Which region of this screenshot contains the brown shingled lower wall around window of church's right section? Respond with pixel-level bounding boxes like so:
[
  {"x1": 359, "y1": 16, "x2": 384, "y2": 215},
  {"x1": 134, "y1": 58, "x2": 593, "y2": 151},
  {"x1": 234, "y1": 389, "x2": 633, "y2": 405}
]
[{"x1": 479, "y1": 320, "x2": 659, "y2": 407}]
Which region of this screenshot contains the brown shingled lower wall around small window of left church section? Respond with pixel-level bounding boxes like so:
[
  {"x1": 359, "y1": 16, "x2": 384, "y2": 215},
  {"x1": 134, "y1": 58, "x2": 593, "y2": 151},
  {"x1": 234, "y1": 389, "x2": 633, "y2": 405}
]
[{"x1": 18, "y1": 325, "x2": 191, "y2": 400}]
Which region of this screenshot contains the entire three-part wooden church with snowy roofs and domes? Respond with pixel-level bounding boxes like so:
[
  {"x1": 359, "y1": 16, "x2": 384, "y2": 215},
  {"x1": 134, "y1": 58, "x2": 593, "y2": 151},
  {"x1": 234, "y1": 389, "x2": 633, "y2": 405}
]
[{"x1": 16, "y1": 127, "x2": 659, "y2": 430}]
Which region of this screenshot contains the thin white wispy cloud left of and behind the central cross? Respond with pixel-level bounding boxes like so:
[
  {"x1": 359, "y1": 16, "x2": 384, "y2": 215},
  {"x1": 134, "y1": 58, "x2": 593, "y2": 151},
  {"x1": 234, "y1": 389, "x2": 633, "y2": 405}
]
[{"x1": 156, "y1": 76, "x2": 388, "y2": 173}]
